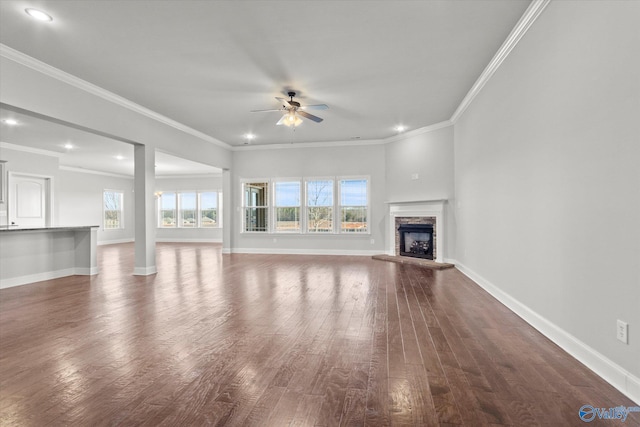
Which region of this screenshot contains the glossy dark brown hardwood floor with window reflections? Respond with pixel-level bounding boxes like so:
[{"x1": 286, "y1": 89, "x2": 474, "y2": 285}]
[{"x1": 0, "y1": 243, "x2": 640, "y2": 426}]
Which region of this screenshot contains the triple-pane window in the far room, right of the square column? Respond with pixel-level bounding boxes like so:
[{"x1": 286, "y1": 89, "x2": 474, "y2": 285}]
[{"x1": 158, "y1": 191, "x2": 222, "y2": 228}]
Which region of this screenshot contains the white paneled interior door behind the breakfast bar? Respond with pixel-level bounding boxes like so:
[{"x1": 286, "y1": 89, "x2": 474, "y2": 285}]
[{"x1": 8, "y1": 174, "x2": 49, "y2": 227}]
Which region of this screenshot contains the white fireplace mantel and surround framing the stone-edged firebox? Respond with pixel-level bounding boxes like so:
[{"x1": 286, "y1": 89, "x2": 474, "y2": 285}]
[{"x1": 386, "y1": 199, "x2": 447, "y2": 262}]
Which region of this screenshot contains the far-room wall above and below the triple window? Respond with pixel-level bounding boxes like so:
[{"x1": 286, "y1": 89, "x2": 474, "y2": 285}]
[{"x1": 156, "y1": 175, "x2": 224, "y2": 242}]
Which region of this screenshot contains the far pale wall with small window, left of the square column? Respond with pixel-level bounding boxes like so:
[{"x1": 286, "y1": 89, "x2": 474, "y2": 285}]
[{"x1": 55, "y1": 168, "x2": 135, "y2": 244}]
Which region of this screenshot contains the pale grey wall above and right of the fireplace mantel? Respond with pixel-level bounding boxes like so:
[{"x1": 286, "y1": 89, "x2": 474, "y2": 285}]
[{"x1": 385, "y1": 126, "x2": 455, "y2": 259}]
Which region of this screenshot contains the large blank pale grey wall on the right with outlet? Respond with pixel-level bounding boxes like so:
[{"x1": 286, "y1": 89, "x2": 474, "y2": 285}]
[{"x1": 454, "y1": 1, "x2": 640, "y2": 399}]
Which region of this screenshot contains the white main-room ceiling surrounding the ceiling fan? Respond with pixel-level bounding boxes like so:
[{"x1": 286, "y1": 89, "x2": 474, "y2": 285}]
[{"x1": 0, "y1": 0, "x2": 530, "y2": 155}]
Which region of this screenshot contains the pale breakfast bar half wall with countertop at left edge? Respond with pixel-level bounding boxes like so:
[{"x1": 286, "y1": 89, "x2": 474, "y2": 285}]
[{"x1": 0, "y1": 226, "x2": 98, "y2": 288}]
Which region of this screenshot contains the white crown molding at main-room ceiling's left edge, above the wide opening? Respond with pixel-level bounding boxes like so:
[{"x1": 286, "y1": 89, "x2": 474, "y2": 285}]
[{"x1": 0, "y1": 43, "x2": 231, "y2": 149}]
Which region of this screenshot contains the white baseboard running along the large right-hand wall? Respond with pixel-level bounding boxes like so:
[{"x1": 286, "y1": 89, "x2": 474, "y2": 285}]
[{"x1": 450, "y1": 260, "x2": 640, "y2": 404}]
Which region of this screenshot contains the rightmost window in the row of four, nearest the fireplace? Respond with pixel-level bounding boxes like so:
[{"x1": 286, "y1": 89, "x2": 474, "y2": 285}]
[{"x1": 339, "y1": 179, "x2": 369, "y2": 233}]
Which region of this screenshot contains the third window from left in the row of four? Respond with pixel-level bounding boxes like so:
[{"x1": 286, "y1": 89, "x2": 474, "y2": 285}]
[{"x1": 306, "y1": 179, "x2": 333, "y2": 233}]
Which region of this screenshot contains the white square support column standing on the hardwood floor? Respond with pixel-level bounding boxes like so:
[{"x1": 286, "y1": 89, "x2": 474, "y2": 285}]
[{"x1": 133, "y1": 145, "x2": 157, "y2": 276}]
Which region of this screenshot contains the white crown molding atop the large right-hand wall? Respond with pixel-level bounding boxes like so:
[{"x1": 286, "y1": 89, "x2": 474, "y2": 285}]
[{"x1": 449, "y1": 0, "x2": 551, "y2": 123}]
